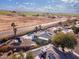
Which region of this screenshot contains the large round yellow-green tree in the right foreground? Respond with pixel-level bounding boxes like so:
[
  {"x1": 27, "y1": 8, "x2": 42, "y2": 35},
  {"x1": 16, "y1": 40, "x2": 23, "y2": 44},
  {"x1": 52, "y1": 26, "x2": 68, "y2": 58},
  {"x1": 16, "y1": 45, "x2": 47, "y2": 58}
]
[{"x1": 52, "y1": 32, "x2": 77, "y2": 51}]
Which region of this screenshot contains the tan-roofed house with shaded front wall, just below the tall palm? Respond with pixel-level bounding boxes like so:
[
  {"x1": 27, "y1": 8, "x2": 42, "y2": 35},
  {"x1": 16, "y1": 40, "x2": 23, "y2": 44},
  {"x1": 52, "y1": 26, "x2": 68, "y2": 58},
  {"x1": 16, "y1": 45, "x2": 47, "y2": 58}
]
[{"x1": 9, "y1": 37, "x2": 37, "y2": 51}]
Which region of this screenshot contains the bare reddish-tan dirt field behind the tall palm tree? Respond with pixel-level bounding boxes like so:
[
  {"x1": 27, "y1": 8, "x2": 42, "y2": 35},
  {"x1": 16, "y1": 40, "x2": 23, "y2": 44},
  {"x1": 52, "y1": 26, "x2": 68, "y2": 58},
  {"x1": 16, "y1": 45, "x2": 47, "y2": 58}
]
[{"x1": 0, "y1": 15, "x2": 59, "y2": 31}]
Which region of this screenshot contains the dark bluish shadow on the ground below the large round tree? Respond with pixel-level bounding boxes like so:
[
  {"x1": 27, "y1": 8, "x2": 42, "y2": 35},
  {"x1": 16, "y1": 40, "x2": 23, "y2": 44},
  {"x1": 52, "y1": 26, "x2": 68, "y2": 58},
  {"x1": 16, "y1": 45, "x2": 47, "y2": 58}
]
[{"x1": 53, "y1": 47, "x2": 79, "y2": 59}]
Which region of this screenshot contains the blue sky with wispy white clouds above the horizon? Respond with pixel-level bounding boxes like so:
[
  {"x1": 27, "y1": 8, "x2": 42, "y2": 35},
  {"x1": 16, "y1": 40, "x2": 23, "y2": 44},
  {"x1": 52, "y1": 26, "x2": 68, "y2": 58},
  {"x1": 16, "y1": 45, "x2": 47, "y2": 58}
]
[{"x1": 0, "y1": 0, "x2": 79, "y2": 13}]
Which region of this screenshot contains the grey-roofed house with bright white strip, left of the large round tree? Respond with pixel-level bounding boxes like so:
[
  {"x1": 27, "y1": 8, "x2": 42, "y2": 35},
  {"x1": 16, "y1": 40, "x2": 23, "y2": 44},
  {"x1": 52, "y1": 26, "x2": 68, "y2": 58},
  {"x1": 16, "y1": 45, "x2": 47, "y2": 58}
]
[{"x1": 33, "y1": 31, "x2": 51, "y2": 45}]
